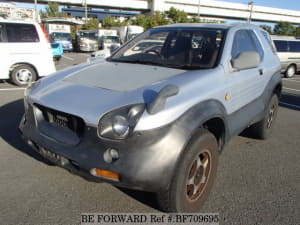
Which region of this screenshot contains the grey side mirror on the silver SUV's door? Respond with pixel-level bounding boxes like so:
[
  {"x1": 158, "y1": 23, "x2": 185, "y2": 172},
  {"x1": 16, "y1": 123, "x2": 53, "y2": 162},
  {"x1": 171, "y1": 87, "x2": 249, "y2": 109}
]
[{"x1": 231, "y1": 52, "x2": 260, "y2": 70}]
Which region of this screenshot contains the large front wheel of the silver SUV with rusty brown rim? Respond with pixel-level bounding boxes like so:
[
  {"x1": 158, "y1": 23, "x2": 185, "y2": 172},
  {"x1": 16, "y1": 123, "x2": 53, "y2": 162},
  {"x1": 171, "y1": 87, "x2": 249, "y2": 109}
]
[{"x1": 157, "y1": 129, "x2": 219, "y2": 212}]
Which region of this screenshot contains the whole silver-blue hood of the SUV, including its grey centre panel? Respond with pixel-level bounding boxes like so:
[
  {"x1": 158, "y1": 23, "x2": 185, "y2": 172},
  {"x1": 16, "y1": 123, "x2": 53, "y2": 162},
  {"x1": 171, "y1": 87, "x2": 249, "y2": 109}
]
[{"x1": 29, "y1": 62, "x2": 185, "y2": 126}]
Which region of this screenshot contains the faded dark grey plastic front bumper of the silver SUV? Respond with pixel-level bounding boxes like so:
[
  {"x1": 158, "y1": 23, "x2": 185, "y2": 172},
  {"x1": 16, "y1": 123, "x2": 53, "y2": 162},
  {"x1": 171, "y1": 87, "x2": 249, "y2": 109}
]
[{"x1": 19, "y1": 105, "x2": 185, "y2": 192}]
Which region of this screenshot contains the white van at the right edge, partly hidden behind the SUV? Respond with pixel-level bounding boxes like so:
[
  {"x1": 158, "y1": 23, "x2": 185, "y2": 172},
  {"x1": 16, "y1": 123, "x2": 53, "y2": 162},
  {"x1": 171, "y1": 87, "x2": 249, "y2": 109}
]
[{"x1": 271, "y1": 35, "x2": 300, "y2": 78}]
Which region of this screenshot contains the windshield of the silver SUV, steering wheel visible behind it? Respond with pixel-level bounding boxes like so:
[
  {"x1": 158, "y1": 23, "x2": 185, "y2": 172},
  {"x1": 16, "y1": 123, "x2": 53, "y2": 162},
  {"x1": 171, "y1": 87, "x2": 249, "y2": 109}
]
[{"x1": 110, "y1": 27, "x2": 225, "y2": 69}]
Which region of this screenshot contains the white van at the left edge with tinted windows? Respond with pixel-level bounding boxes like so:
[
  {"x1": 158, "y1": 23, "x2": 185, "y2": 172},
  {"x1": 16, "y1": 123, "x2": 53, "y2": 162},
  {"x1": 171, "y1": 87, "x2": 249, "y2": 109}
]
[{"x1": 0, "y1": 19, "x2": 55, "y2": 86}]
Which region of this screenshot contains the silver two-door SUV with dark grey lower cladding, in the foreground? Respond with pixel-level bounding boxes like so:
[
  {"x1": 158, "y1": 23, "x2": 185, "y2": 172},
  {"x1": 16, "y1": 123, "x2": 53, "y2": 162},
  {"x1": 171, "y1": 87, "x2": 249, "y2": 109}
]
[{"x1": 20, "y1": 24, "x2": 281, "y2": 212}]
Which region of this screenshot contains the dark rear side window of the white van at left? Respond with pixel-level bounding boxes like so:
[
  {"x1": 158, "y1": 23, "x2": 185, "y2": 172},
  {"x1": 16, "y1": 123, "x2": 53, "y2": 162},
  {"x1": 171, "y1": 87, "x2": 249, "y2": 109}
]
[{"x1": 6, "y1": 23, "x2": 39, "y2": 42}]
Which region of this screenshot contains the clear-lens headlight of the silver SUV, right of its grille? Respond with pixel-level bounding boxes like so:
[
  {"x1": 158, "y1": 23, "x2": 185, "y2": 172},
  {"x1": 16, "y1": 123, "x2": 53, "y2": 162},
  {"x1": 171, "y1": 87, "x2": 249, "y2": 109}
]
[{"x1": 98, "y1": 104, "x2": 145, "y2": 139}]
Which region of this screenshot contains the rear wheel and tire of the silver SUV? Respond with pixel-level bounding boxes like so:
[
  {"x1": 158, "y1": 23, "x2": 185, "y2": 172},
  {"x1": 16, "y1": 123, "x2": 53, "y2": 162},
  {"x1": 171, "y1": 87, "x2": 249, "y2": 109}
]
[{"x1": 251, "y1": 94, "x2": 278, "y2": 140}]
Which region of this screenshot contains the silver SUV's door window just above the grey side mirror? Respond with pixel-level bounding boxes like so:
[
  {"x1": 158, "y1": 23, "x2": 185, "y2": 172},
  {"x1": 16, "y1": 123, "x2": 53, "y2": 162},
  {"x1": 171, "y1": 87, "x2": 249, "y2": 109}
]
[{"x1": 231, "y1": 30, "x2": 259, "y2": 59}]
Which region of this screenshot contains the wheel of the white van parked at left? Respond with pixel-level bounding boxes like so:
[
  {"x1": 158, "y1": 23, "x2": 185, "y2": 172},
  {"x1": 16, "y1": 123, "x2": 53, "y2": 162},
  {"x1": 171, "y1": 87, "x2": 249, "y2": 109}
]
[{"x1": 11, "y1": 65, "x2": 37, "y2": 87}]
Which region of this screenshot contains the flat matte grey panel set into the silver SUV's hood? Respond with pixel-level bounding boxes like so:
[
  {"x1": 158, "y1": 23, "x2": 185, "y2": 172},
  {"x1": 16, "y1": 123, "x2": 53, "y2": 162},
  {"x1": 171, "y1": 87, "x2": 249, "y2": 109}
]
[{"x1": 64, "y1": 62, "x2": 184, "y2": 92}]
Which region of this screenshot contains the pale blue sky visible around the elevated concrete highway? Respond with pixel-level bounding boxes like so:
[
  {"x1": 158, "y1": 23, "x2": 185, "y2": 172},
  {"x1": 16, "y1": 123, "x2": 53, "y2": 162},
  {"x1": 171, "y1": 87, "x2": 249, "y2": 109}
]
[{"x1": 17, "y1": 0, "x2": 300, "y2": 11}]
